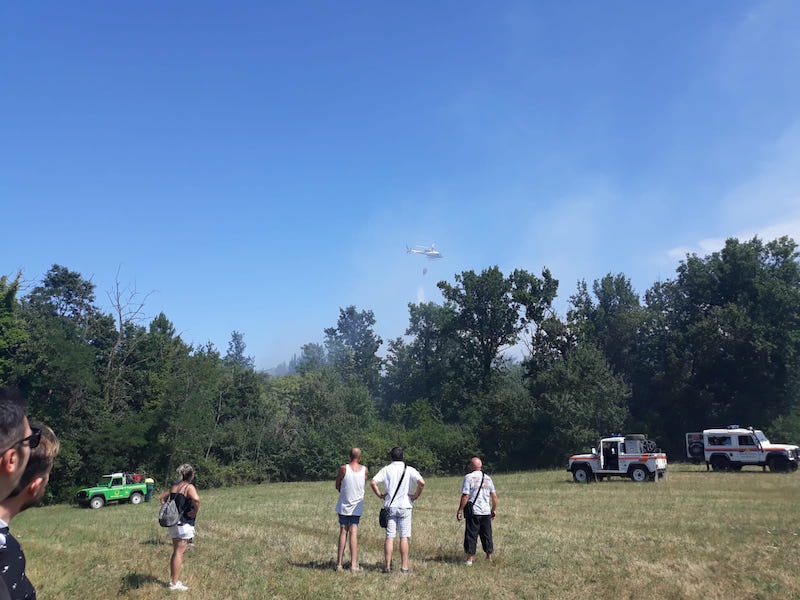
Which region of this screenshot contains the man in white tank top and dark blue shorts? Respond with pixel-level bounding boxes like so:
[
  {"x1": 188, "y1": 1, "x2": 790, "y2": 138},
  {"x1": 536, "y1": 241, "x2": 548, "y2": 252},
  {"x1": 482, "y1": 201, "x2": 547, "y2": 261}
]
[{"x1": 336, "y1": 448, "x2": 367, "y2": 571}]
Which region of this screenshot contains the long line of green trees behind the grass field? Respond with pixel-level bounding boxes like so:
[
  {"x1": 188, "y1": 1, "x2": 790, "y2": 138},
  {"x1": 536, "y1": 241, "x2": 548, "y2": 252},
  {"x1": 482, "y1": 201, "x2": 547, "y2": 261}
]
[{"x1": 0, "y1": 237, "x2": 800, "y2": 501}]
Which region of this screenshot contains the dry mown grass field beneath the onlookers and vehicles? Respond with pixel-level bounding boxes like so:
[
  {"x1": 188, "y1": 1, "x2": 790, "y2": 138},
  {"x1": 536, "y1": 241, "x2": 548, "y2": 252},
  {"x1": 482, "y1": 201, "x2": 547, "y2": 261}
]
[{"x1": 12, "y1": 465, "x2": 800, "y2": 600}]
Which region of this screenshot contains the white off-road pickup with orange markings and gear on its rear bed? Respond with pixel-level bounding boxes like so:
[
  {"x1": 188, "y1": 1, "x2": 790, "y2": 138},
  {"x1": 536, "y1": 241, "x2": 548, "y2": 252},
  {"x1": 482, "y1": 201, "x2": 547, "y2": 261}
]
[{"x1": 567, "y1": 433, "x2": 667, "y2": 483}]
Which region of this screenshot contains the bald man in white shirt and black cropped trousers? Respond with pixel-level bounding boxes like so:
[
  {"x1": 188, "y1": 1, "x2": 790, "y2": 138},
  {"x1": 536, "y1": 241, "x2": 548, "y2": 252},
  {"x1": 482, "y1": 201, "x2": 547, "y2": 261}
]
[{"x1": 456, "y1": 456, "x2": 497, "y2": 566}]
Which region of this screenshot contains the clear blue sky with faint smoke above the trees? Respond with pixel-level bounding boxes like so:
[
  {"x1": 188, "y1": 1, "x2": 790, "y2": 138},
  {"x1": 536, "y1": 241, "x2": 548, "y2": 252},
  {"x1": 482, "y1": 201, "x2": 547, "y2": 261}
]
[{"x1": 0, "y1": 0, "x2": 800, "y2": 368}]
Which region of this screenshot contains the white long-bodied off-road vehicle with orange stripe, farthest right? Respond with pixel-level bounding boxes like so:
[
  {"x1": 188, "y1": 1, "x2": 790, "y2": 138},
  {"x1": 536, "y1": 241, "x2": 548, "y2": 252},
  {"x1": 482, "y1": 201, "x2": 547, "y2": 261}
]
[{"x1": 686, "y1": 425, "x2": 800, "y2": 473}]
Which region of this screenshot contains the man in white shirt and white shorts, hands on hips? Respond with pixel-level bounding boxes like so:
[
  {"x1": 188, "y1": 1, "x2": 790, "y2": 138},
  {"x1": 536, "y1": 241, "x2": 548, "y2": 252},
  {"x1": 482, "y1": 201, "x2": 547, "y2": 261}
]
[{"x1": 369, "y1": 446, "x2": 425, "y2": 574}]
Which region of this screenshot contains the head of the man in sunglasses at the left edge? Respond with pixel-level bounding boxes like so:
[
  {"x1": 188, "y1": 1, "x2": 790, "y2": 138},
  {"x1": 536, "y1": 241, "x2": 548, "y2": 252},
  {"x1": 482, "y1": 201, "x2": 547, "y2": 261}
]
[{"x1": 0, "y1": 388, "x2": 41, "y2": 500}]
